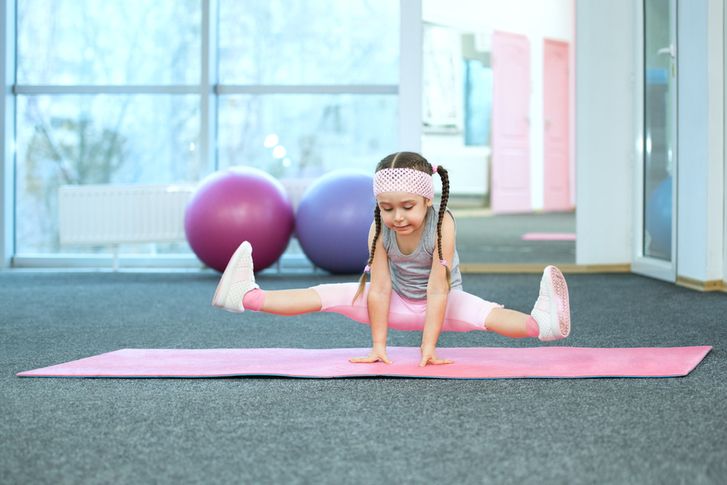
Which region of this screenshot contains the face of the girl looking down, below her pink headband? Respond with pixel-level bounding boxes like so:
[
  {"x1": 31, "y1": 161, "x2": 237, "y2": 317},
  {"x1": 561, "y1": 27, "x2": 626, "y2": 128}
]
[{"x1": 376, "y1": 192, "x2": 432, "y2": 236}]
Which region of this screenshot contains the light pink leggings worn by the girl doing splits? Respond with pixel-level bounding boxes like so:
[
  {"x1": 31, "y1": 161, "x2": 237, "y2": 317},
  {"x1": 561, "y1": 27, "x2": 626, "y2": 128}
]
[{"x1": 312, "y1": 283, "x2": 502, "y2": 332}]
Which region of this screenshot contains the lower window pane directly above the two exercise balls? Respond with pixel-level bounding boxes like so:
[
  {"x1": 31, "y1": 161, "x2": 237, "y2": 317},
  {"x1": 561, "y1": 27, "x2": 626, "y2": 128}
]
[{"x1": 218, "y1": 95, "x2": 397, "y2": 178}]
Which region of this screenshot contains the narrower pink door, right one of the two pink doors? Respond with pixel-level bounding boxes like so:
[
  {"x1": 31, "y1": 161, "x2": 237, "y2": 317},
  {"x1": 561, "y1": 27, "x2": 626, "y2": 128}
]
[{"x1": 543, "y1": 40, "x2": 573, "y2": 211}]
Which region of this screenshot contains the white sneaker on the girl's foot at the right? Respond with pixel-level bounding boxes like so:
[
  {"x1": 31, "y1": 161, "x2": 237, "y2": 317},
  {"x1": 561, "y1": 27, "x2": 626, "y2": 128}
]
[{"x1": 530, "y1": 266, "x2": 570, "y2": 342}]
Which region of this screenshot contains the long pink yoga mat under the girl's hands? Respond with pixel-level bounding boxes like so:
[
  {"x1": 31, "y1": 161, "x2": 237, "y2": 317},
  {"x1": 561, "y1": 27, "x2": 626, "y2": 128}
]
[{"x1": 18, "y1": 346, "x2": 712, "y2": 379}]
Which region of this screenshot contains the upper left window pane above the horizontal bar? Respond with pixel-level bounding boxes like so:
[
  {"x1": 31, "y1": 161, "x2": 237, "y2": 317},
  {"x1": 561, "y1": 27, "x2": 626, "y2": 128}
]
[{"x1": 17, "y1": 0, "x2": 201, "y2": 85}]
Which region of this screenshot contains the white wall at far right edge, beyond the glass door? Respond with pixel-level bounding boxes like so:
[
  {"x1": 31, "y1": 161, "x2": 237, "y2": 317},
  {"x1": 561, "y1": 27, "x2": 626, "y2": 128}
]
[{"x1": 677, "y1": 0, "x2": 725, "y2": 281}]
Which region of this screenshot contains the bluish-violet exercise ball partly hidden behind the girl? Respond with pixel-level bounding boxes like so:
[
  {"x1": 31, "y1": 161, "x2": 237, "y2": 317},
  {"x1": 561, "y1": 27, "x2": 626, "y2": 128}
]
[{"x1": 295, "y1": 170, "x2": 375, "y2": 274}]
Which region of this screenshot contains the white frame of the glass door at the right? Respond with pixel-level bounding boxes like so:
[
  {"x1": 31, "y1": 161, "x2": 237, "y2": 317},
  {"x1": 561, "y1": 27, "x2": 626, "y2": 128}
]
[{"x1": 631, "y1": 0, "x2": 679, "y2": 283}]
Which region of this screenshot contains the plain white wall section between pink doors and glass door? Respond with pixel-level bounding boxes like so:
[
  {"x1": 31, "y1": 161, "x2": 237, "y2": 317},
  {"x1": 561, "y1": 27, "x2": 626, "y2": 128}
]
[{"x1": 575, "y1": 0, "x2": 636, "y2": 264}]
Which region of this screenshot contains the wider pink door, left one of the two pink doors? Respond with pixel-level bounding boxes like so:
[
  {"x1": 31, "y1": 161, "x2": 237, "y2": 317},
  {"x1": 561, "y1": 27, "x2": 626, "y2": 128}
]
[{"x1": 491, "y1": 32, "x2": 532, "y2": 213}]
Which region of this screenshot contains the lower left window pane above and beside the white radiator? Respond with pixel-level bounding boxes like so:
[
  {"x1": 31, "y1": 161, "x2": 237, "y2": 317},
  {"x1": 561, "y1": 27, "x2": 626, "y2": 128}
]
[{"x1": 16, "y1": 95, "x2": 200, "y2": 253}]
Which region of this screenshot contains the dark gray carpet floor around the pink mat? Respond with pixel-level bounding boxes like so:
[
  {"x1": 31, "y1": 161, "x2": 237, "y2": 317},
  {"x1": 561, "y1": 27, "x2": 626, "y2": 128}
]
[{"x1": 0, "y1": 271, "x2": 727, "y2": 484}]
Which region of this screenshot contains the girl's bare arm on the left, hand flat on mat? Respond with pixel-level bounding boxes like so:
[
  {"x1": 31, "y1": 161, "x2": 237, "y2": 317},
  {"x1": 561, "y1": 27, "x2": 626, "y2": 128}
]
[{"x1": 350, "y1": 224, "x2": 391, "y2": 364}]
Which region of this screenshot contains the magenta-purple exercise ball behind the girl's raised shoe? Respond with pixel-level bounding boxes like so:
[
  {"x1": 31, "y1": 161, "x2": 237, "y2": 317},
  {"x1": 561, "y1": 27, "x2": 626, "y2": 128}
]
[{"x1": 184, "y1": 167, "x2": 295, "y2": 271}]
